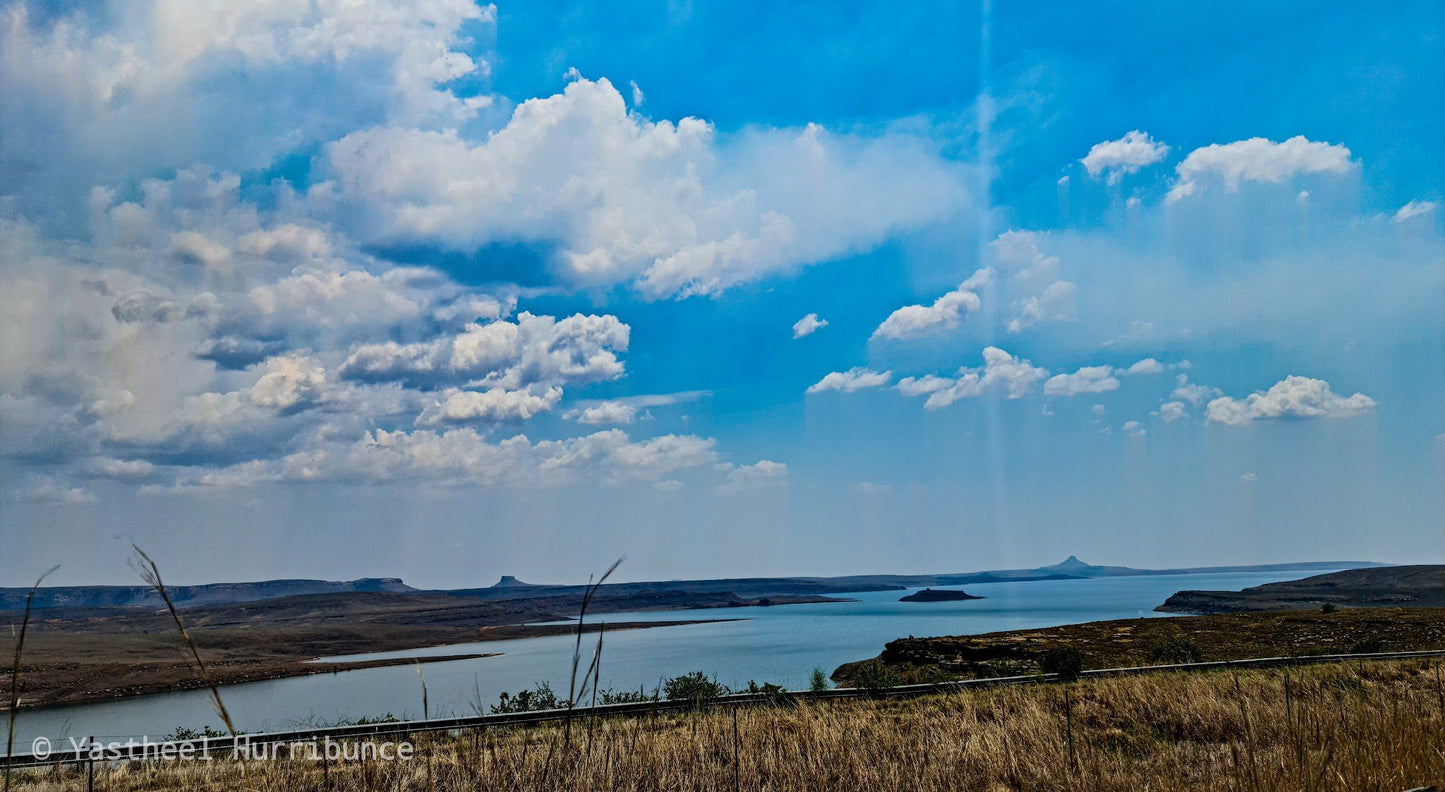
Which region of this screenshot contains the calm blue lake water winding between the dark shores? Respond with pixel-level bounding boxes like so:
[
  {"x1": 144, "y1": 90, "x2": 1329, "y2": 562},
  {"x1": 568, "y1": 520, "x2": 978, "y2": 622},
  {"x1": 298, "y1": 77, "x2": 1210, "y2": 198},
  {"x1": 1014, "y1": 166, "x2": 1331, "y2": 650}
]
[{"x1": 5, "y1": 572, "x2": 1318, "y2": 752}]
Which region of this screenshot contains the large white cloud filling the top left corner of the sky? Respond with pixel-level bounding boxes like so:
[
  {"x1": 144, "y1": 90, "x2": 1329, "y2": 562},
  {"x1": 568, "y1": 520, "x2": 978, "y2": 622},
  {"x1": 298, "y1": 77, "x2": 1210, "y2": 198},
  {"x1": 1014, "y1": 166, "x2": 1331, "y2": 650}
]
[{"x1": 0, "y1": 0, "x2": 496, "y2": 218}]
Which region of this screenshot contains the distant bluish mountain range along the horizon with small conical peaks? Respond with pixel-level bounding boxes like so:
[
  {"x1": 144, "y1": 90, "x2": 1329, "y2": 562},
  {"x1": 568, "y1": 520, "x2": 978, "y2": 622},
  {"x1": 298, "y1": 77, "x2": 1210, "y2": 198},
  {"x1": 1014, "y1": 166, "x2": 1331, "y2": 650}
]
[{"x1": 0, "y1": 555, "x2": 1386, "y2": 610}]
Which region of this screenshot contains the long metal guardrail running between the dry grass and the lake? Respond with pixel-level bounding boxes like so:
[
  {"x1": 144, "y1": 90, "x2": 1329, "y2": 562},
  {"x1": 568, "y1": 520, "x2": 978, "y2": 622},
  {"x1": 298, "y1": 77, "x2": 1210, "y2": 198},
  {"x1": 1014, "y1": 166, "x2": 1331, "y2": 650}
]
[{"x1": 0, "y1": 649, "x2": 1445, "y2": 767}]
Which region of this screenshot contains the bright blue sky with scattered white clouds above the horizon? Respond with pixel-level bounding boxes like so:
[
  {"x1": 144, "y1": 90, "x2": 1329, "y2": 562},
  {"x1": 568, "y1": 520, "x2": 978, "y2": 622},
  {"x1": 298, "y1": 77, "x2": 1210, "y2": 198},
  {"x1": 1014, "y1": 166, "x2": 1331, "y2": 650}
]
[{"x1": 0, "y1": 0, "x2": 1445, "y2": 587}]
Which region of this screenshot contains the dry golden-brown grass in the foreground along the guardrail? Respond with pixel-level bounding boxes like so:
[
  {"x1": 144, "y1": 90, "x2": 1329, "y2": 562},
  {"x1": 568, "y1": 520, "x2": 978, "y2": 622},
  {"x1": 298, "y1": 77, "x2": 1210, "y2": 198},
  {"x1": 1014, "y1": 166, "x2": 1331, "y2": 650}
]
[{"x1": 5, "y1": 660, "x2": 1445, "y2": 792}]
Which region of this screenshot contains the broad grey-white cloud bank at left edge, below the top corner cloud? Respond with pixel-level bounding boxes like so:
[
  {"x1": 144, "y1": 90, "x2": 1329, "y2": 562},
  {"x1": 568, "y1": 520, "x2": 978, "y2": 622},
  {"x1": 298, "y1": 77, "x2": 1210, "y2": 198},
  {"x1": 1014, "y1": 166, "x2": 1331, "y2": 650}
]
[{"x1": 0, "y1": 184, "x2": 670, "y2": 491}]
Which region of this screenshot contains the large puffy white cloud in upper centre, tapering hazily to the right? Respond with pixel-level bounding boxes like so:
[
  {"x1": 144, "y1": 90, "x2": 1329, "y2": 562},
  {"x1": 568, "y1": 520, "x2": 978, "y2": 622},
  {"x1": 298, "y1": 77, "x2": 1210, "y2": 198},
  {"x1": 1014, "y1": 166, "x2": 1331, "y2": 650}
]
[{"x1": 318, "y1": 78, "x2": 965, "y2": 296}]
